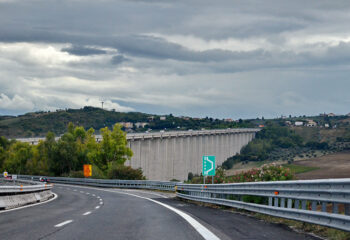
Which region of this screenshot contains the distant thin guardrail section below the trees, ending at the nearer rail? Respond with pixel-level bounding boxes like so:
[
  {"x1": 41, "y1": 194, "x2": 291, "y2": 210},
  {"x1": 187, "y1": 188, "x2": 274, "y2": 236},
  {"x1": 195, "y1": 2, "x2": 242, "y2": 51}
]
[{"x1": 18, "y1": 175, "x2": 176, "y2": 191}]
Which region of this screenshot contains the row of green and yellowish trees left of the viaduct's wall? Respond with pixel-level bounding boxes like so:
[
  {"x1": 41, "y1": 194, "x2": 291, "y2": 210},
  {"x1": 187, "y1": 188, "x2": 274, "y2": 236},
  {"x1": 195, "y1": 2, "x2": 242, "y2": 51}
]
[{"x1": 0, "y1": 123, "x2": 144, "y2": 179}]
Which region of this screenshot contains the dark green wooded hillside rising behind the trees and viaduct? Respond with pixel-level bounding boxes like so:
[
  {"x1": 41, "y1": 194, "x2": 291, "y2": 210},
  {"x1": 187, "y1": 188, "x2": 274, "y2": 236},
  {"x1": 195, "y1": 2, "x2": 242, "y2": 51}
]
[{"x1": 0, "y1": 107, "x2": 255, "y2": 138}]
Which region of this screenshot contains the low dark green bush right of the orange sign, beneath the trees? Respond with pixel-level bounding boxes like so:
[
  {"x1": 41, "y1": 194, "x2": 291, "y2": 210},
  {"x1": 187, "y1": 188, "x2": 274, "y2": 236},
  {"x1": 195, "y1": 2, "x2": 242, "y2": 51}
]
[{"x1": 107, "y1": 165, "x2": 146, "y2": 180}]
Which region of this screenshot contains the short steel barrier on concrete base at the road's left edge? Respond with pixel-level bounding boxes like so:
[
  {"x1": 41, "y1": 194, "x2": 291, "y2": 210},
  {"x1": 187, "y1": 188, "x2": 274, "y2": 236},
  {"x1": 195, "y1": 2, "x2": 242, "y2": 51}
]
[{"x1": 0, "y1": 179, "x2": 53, "y2": 210}]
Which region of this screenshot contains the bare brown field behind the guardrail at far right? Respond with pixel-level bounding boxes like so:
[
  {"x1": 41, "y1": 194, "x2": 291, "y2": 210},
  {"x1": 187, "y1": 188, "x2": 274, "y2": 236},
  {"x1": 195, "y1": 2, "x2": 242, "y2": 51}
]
[{"x1": 293, "y1": 151, "x2": 350, "y2": 179}]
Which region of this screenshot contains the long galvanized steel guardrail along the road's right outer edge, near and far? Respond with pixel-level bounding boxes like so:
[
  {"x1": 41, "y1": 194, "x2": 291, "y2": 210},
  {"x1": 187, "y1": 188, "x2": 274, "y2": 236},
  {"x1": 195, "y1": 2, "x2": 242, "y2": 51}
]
[{"x1": 12, "y1": 176, "x2": 350, "y2": 231}]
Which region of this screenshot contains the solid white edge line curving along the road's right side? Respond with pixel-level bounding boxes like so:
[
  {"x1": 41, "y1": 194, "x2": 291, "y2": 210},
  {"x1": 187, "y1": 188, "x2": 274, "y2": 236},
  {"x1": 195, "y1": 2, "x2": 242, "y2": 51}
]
[{"x1": 115, "y1": 190, "x2": 220, "y2": 240}]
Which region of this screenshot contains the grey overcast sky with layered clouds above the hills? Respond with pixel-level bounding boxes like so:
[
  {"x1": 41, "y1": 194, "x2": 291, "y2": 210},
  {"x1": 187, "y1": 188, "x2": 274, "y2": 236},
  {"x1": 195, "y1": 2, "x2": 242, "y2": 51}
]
[{"x1": 0, "y1": 0, "x2": 350, "y2": 119}]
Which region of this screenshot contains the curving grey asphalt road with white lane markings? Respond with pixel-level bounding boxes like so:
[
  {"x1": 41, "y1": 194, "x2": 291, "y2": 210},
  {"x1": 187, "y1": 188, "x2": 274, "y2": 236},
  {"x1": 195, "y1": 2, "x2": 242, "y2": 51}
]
[{"x1": 0, "y1": 185, "x2": 322, "y2": 240}]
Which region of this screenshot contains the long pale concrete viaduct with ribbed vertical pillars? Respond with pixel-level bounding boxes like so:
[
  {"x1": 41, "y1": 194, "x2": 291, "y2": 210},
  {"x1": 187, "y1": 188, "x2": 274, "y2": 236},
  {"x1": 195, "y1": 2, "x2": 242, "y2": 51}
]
[{"x1": 17, "y1": 128, "x2": 259, "y2": 181}]
